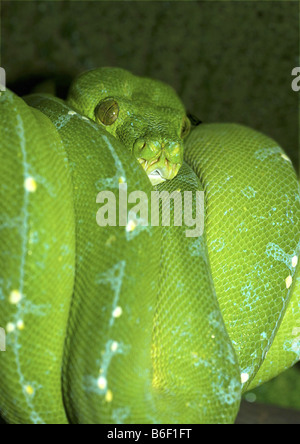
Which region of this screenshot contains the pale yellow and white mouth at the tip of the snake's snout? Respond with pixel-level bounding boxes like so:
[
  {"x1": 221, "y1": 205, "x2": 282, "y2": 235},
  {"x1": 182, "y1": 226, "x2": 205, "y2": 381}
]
[{"x1": 138, "y1": 156, "x2": 181, "y2": 185}]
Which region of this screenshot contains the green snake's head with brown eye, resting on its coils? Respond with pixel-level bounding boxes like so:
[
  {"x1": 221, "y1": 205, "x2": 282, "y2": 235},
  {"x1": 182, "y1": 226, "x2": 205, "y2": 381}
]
[{"x1": 68, "y1": 68, "x2": 191, "y2": 185}]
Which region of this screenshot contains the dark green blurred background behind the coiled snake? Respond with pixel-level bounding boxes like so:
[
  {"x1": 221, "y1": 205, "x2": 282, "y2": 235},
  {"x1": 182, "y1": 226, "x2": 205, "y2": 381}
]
[{"x1": 0, "y1": 1, "x2": 300, "y2": 424}]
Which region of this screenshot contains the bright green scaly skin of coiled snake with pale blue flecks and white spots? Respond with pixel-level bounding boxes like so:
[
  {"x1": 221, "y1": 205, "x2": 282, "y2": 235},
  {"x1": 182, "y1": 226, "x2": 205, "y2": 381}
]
[{"x1": 0, "y1": 68, "x2": 300, "y2": 424}]
